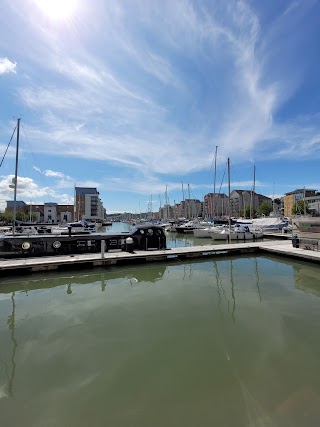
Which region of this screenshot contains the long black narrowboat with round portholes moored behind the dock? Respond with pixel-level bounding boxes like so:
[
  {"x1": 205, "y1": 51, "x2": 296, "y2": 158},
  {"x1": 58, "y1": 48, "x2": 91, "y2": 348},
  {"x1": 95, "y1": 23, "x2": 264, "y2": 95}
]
[{"x1": 0, "y1": 224, "x2": 167, "y2": 258}]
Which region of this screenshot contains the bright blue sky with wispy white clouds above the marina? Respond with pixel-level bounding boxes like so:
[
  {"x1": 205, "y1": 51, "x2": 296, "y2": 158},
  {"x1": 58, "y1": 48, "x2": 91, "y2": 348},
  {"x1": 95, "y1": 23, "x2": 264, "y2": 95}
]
[{"x1": 0, "y1": 0, "x2": 320, "y2": 213}]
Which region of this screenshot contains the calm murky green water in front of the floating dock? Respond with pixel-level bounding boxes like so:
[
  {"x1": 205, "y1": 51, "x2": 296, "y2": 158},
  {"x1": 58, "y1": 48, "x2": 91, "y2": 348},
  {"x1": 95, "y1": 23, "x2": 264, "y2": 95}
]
[{"x1": 0, "y1": 257, "x2": 320, "y2": 427}]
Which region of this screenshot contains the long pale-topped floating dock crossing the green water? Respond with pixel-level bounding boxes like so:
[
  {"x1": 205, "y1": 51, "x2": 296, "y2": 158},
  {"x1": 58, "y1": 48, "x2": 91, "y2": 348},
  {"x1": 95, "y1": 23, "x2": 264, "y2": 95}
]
[{"x1": 0, "y1": 240, "x2": 320, "y2": 277}]
